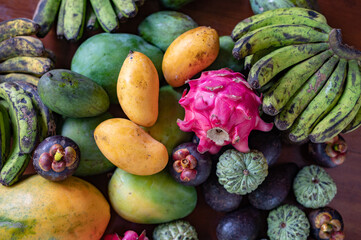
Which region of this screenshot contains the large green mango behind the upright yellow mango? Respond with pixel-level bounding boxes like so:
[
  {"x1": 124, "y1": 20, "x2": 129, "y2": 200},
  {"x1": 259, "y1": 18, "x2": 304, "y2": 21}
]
[{"x1": 71, "y1": 33, "x2": 163, "y2": 104}]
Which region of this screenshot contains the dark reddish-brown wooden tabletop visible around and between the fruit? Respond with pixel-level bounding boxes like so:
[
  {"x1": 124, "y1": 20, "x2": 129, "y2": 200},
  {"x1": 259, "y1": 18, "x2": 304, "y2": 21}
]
[{"x1": 0, "y1": 0, "x2": 361, "y2": 240}]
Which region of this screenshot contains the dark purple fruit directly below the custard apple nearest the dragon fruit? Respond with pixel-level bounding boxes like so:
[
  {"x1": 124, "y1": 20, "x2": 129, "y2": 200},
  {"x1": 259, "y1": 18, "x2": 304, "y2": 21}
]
[{"x1": 202, "y1": 176, "x2": 242, "y2": 212}]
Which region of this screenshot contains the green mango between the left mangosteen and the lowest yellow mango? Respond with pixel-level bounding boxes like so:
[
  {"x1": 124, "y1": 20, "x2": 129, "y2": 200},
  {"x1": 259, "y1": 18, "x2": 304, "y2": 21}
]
[{"x1": 61, "y1": 112, "x2": 115, "y2": 176}]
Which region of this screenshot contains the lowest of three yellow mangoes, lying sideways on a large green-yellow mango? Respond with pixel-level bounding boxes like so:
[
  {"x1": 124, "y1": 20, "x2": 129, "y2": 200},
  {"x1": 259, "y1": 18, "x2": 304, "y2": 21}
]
[{"x1": 94, "y1": 118, "x2": 168, "y2": 175}]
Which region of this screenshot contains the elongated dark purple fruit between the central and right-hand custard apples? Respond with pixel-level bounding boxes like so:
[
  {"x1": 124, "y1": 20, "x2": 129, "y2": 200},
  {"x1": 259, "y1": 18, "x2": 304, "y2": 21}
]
[{"x1": 248, "y1": 163, "x2": 299, "y2": 210}]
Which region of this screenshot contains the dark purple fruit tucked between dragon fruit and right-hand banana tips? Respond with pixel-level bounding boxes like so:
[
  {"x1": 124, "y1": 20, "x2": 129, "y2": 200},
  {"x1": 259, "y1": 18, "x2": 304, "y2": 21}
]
[{"x1": 248, "y1": 128, "x2": 282, "y2": 166}]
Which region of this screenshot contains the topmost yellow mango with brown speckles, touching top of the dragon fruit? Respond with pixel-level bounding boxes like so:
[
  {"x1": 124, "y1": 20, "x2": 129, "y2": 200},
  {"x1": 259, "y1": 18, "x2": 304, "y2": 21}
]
[{"x1": 162, "y1": 26, "x2": 219, "y2": 87}]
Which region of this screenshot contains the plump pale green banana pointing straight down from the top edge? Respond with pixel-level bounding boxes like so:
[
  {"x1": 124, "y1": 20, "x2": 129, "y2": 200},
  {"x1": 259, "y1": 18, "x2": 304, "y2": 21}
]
[{"x1": 64, "y1": 0, "x2": 86, "y2": 42}]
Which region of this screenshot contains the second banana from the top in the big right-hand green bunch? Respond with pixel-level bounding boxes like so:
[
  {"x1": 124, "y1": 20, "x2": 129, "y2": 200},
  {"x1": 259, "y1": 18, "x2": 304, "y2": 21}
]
[{"x1": 232, "y1": 25, "x2": 329, "y2": 60}]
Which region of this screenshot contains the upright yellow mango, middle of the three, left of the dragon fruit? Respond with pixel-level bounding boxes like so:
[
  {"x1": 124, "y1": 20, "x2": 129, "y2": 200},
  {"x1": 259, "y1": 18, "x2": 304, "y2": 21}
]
[{"x1": 117, "y1": 51, "x2": 159, "y2": 127}]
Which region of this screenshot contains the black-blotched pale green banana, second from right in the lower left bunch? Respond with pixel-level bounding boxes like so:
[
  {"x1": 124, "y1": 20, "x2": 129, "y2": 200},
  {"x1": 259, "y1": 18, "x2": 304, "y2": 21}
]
[{"x1": 0, "y1": 82, "x2": 37, "y2": 153}]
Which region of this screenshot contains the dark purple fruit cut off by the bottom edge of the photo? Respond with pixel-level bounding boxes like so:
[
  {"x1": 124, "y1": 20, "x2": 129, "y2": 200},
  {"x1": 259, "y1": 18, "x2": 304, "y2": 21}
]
[{"x1": 216, "y1": 207, "x2": 262, "y2": 240}]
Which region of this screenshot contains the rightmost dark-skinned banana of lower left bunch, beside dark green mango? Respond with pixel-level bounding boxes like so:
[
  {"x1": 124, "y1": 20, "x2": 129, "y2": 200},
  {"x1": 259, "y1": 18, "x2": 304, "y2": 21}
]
[{"x1": 14, "y1": 81, "x2": 56, "y2": 142}]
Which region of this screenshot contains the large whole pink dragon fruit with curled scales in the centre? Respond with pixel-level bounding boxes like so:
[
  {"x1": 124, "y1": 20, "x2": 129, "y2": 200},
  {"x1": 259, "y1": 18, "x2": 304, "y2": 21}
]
[{"x1": 177, "y1": 68, "x2": 273, "y2": 154}]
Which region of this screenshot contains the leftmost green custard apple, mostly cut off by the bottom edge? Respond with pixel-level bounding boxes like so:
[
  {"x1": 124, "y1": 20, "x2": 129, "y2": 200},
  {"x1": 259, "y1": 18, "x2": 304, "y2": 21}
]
[{"x1": 153, "y1": 220, "x2": 198, "y2": 240}]
